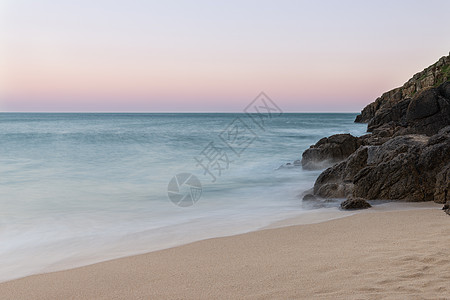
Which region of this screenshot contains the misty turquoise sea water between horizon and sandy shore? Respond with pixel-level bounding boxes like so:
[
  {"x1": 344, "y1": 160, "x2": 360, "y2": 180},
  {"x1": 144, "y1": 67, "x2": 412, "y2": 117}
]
[{"x1": 0, "y1": 113, "x2": 366, "y2": 281}]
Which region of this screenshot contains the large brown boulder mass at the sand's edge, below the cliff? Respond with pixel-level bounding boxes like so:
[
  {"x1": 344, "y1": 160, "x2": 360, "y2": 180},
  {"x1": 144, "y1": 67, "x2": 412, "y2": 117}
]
[{"x1": 314, "y1": 130, "x2": 450, "y2": 203}]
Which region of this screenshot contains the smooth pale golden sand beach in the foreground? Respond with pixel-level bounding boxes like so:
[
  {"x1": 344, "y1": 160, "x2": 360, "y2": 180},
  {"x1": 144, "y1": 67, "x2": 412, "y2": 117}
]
[{"x1": 0, "y1": 208, "x2": 450, "y2": 299}]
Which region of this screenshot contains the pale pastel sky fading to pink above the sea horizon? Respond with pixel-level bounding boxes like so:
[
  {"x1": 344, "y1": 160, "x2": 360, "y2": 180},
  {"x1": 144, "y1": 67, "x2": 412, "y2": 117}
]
[{"x1": 0, "y1": 0, "x2": 450, "y2": 112}]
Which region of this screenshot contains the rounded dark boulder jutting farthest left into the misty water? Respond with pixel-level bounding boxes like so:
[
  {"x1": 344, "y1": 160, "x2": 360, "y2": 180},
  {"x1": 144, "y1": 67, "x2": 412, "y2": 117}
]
[{"x1": 302, "y1": 134, "x2": 361, "y2": 170}]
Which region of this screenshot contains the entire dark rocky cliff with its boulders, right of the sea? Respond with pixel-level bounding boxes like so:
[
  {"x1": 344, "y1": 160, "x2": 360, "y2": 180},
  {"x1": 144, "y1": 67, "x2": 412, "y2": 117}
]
[{"x1": 302, "y1": 52, "x2": 450, "y2": 213}]
